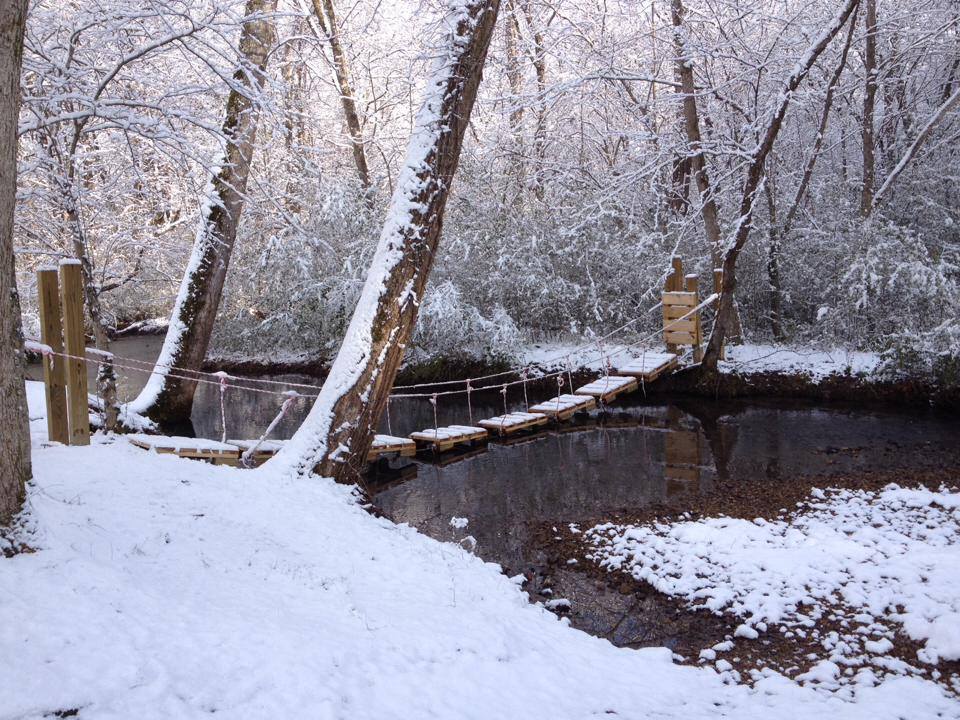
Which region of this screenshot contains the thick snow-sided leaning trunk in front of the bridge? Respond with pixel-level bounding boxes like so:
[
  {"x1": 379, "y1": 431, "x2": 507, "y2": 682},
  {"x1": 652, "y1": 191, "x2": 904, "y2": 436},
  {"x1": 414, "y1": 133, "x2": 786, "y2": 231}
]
[{"x1": 265, "y1": 0, "x2": 500, "y2": 480}]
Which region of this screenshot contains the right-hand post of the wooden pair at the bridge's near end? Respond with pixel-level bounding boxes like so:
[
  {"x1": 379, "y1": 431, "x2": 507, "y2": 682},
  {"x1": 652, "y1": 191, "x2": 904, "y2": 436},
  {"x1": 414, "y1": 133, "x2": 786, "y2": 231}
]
[{"x1": 60, "y1": 260, "x2": 90, "y2": 445}]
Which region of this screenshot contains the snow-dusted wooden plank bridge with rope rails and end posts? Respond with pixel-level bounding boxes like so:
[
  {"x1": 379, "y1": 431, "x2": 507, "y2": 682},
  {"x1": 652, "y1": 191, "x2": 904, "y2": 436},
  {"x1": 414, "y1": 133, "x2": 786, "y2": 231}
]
[{"x1": 32, "y1": 257, "x2": 721, "y2": 467}]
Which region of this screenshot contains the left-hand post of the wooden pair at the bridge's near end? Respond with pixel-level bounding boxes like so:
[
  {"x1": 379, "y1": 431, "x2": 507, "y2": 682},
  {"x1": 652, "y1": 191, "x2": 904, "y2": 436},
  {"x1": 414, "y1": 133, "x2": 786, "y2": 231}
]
[{"x1": 37, "y1": 268, "x2": 70, "y2": 445}]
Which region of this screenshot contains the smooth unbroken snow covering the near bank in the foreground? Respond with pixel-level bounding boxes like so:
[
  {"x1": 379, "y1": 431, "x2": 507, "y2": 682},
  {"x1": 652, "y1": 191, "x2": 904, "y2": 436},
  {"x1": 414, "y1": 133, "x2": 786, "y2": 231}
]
[{"x1": 0, "y1": 387, "x2": 960, "y2": 720}]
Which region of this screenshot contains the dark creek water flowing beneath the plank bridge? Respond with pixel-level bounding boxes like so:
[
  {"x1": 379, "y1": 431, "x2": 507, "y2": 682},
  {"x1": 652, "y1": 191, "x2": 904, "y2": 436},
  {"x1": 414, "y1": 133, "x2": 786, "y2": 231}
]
[{"x1": 28, "y1": 338, "x2": 960, "y2": 645}]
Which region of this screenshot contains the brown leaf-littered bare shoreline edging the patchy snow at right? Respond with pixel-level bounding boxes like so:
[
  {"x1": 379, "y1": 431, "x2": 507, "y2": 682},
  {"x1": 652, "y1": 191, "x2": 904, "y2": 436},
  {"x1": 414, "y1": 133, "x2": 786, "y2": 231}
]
[{"x1": 522, "y1": 466, "x2": 960, "y2": 694}]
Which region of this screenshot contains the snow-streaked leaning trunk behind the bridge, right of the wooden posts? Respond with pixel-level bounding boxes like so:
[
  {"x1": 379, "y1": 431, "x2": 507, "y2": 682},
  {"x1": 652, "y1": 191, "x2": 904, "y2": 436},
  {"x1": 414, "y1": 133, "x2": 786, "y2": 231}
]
[{"x1": 130, "y1": 0, "x2": 277, "y2": 425}]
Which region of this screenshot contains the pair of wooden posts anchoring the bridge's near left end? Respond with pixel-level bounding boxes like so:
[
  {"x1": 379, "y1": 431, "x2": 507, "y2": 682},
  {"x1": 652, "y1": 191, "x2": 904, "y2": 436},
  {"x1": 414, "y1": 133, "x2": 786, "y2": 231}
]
[{"x1": 37, "y1": 260, "x2": 90, "y2": 445}]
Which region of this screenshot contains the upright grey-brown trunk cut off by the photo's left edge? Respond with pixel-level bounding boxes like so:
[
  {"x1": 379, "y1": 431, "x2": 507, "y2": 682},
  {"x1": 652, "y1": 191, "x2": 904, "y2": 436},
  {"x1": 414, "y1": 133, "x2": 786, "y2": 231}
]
[{"x1": 0, "y1": 0, "x2": 30, "y2": 525}]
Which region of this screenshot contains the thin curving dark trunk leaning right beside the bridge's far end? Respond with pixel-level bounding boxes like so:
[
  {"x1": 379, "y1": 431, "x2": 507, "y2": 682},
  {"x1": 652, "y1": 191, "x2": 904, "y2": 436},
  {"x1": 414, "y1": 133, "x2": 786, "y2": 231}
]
[{"x1": 701, "y1": 0, "x2": 860, "y2": 374}]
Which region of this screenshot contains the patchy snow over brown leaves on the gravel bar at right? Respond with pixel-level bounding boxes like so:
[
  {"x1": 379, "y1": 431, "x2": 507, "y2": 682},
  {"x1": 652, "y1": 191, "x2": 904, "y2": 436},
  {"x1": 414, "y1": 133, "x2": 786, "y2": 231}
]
[{"x1": 584, "y1": 485, "x2": 960, "y2": 688}]
